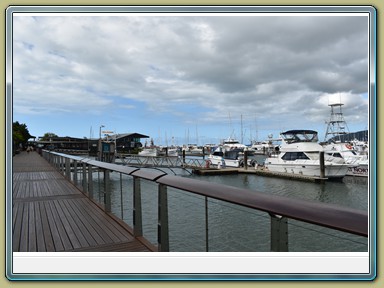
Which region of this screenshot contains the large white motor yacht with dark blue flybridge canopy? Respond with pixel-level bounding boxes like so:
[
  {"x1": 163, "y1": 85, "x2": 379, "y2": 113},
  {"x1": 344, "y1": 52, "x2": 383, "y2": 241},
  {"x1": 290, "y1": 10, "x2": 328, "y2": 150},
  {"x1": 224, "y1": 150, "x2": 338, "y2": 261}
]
[{"x1": 265, "y1": 130, "x2": 348, "y2": 179}]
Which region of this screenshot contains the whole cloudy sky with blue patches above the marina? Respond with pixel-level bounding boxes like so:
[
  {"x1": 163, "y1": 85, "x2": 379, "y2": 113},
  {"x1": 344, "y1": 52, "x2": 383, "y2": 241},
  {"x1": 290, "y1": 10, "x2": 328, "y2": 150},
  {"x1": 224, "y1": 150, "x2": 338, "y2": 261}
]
[{"x1": 13, "y1": 14, "x2": 369, "y2": 145}]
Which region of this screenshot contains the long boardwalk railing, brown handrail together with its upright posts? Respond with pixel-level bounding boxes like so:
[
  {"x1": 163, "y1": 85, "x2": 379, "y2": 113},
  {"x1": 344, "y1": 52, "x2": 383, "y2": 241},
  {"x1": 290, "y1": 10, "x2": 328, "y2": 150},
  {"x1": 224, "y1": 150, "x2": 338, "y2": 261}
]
[{"x1": 42, "y1": 150, "x2": 368, "y2": 252}]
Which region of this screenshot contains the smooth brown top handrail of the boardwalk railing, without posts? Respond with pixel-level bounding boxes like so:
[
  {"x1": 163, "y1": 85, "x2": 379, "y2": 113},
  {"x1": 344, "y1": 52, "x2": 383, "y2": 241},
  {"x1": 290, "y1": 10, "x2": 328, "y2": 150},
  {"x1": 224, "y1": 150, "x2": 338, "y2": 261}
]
[{"x1": 42, "y1": 152, "x2": 368, "y2": 237}]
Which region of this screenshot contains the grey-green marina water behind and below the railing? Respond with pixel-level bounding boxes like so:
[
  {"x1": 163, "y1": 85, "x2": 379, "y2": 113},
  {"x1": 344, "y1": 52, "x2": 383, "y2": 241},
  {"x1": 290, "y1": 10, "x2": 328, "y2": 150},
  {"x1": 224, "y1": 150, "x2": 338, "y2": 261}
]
[{"x1": 88, "y1": 158, "x2": 369, "y2": 252}]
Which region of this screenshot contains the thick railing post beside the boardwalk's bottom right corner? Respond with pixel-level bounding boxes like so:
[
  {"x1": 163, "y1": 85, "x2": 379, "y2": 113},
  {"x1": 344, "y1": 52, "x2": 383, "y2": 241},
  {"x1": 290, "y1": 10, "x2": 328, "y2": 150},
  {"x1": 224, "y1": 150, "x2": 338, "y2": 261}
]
[{"x1": 157, "y1": 184, "x2": 169, "y2": 252}]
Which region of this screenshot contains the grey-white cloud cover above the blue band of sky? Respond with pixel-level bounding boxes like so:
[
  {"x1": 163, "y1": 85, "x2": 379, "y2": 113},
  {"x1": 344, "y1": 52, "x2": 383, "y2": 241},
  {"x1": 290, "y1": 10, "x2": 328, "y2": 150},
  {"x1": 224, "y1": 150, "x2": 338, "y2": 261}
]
[{"x1": 13, "y1": 12, "x2": 368, "y2": 136}]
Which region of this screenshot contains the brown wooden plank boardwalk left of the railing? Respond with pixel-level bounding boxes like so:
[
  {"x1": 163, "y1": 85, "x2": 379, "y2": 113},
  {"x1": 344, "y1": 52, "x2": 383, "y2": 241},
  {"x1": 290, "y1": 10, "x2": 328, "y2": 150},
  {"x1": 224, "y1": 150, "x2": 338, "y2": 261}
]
[{"x1": 12, "y1": 152, "x2": 153, "y2": 252}]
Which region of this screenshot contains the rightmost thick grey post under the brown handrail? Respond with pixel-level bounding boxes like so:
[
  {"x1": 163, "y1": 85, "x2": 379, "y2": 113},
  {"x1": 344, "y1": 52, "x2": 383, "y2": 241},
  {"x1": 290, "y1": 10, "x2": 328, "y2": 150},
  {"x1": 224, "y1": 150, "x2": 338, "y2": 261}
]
[{"x1": 269, "y1": 214, "x2": 288, "y2": 252}]
